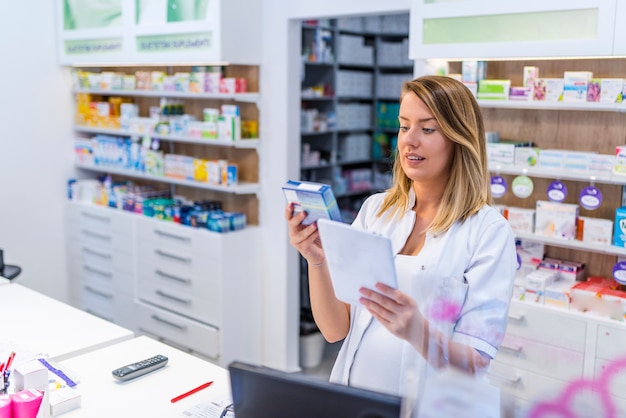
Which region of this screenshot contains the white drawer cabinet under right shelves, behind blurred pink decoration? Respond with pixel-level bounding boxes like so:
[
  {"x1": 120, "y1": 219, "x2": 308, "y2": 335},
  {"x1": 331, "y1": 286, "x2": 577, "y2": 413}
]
[{"x1": 489, "y1": 301, "x2": 626, "y2": 416}]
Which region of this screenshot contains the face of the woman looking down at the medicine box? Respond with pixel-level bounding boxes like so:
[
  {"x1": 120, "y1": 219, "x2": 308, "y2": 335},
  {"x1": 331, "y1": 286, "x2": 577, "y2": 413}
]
[{"x1": 398, "y1": 92, "x2": 454, "y2": 182}]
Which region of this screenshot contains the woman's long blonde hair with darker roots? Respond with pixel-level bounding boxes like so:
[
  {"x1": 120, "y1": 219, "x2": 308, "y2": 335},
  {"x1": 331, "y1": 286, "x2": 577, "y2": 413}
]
[{"x1": 377, "y1": 76, "x2": 492, "y2": 232}]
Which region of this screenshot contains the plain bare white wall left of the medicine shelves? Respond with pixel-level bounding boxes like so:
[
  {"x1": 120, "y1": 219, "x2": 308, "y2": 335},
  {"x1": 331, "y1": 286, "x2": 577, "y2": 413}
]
[{"x1": 0, "y1": 1, "x2": 73, "y2": 300}]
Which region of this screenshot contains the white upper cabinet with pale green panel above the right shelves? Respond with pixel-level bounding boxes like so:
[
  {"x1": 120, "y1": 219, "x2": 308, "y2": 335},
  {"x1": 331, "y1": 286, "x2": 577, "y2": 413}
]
[{"x1": 410, "y1": 0, "x2": 625, "y2": 59}]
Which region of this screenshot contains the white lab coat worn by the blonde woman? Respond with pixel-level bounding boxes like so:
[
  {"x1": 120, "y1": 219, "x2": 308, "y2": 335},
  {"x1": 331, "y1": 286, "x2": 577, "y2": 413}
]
[{"x1": 330, "y1": 190, "x2": 517, "y2": 396}]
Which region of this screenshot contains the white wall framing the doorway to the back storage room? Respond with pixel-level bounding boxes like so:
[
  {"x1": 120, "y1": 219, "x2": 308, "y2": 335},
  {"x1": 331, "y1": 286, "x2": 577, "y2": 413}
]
[{"x1": 260, "y1": 0, "x2": 410, "y2": 370}]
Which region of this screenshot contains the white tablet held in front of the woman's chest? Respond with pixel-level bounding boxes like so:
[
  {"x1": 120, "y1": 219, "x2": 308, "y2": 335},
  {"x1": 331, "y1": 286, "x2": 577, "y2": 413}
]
[{"x1": 317, "y1": 219, "x2": 398, "y2": 304}]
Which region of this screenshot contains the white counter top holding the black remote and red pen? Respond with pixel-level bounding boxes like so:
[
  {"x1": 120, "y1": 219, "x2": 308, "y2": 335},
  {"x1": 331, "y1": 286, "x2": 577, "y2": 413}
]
[{"x1": 59, "y1": 336, "x2": 231, "y2": 418}]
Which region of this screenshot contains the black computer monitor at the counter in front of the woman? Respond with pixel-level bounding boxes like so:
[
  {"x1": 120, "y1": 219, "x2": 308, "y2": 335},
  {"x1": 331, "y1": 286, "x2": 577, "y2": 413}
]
[{"x1": 228, "y1": 361, "x2": 402, "y2": 418}]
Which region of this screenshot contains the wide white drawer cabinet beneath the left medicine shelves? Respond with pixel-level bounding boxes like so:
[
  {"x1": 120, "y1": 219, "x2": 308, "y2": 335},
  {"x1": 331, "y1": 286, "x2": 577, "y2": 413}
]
[{"x1": 68, "y1": 203, "x2": 261, "y2": 366}]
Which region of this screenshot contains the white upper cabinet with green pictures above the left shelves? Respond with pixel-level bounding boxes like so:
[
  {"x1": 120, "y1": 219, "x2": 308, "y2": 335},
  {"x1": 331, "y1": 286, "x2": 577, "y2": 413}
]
[{"x1": 56, "y1": 0, "x2": 262, "y2": 65}]
